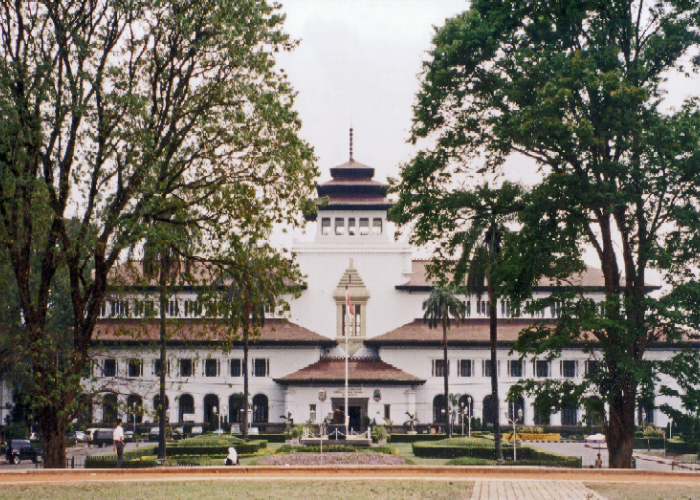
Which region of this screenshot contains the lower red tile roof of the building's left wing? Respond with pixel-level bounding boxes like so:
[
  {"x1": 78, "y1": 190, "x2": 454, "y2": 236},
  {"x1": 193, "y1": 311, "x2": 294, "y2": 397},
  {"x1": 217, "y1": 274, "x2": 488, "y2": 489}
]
[{"x1": 94, "y1": 319, "x2": 335, "y2": 347}]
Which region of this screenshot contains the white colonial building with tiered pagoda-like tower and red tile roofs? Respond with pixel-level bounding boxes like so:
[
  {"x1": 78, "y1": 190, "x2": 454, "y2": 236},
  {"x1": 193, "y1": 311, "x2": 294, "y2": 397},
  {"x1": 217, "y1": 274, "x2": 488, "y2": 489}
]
[{"x1": 86, "y1": 150, "x2": 680, "y2": 432}]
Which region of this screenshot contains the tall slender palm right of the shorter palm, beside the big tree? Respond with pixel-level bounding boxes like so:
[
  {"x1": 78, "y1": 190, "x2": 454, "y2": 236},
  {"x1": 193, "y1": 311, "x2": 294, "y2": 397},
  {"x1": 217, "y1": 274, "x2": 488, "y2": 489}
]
[{"x1": 453, "y1": 181, "x2": 523, "y2": 460}]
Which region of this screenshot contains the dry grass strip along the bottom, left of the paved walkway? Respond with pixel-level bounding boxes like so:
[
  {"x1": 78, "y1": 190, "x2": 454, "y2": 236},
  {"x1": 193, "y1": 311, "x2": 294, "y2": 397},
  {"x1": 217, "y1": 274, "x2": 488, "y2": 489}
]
[{"x1": 0, "y1": 480, "x2": 473, "y2": 500}]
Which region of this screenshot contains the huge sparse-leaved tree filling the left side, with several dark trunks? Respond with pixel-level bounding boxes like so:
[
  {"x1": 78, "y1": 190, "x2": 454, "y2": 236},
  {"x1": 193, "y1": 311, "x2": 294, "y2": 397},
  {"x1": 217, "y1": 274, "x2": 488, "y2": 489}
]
[{"x1": 0, "y1": 0, "x2": 316, "y2": 467}]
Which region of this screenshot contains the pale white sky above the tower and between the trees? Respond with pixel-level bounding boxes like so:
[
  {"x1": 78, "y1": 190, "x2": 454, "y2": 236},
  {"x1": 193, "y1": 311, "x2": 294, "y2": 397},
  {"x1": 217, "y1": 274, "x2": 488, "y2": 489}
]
[{"x1": 274, "y1": 0, "x2": 700, "y2": 278}]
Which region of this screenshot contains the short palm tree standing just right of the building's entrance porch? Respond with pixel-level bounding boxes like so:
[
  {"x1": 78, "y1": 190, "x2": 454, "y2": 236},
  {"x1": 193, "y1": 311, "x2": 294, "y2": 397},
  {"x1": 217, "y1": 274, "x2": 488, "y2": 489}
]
[{"x1": 423, "y1": 285, "x2": 466, "y2": 438}]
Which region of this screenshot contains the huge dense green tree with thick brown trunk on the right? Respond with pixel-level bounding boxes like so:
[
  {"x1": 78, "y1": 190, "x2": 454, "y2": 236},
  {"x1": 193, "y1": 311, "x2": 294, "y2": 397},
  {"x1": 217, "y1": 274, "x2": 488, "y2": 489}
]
[{"x1": 396, "y1": 0, "x2": 700, "y2": 468}]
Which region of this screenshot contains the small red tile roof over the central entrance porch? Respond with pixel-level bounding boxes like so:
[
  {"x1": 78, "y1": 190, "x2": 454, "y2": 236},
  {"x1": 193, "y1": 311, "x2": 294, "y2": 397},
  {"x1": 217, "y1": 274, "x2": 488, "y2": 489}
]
[{"x1": 275, "y1": 358, "x2": 425, "y2": 384}]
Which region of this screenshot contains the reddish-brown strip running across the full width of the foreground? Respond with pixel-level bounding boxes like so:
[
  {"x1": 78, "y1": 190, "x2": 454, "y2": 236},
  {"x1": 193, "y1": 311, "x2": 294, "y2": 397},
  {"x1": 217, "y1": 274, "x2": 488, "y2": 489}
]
[{"x1": 0, "y1": 465, "x2": 700, "y2": 486}]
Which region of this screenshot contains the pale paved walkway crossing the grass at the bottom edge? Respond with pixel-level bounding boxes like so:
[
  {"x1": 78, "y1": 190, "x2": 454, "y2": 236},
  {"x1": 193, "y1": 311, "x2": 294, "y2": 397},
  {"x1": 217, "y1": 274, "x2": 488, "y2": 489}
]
[{"x1": 472, "y1": 480, "x2": 603, "y2": 500}]
